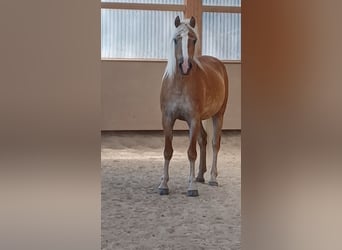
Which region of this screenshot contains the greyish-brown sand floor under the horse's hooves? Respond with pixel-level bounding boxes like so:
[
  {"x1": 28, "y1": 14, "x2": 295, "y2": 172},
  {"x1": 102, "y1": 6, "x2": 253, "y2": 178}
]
[{"x1": 101, "y1": 131, "x2": 241, "y2": 250}]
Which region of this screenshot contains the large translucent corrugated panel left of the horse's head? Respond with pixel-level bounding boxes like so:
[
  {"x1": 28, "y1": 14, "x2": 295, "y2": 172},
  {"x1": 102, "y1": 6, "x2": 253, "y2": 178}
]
[{"x1": 101, "y1": 9, "x2": 183, "y2": 59}]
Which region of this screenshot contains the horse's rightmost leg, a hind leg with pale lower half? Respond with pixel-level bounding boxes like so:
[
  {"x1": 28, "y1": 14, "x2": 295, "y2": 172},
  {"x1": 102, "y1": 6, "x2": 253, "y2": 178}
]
[{"x1": 208, "y1": 114, "x2": 223, "y2": 186}]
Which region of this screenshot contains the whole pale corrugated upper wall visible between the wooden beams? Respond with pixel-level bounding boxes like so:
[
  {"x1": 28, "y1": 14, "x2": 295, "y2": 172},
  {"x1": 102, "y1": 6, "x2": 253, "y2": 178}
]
[{"x1": 101, "y1": 0, "x2": 241, "y2": 60}]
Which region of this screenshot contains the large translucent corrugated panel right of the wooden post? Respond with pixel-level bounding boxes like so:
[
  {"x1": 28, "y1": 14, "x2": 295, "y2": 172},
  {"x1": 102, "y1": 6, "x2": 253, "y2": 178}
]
[{"x1": 202, "y1": 12, "x2": 241, "y2": 60}]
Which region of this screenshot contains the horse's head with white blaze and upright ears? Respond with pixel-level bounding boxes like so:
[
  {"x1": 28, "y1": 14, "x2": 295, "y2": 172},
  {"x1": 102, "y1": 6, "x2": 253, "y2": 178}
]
[{"x1": 173, "y1": 16, "x2": 197, "y2": 75}]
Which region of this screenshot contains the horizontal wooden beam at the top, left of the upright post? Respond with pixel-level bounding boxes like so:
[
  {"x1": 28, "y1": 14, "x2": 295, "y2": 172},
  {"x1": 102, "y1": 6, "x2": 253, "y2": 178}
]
[{"x1": 101, "y1": 3, "x2": 185, "y2": 11}]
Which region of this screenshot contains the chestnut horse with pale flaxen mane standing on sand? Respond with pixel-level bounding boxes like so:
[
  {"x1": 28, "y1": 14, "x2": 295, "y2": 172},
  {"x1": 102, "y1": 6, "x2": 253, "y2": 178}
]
[{"x1": 158, "y1": 16, "x2": 228, "y2": 197}]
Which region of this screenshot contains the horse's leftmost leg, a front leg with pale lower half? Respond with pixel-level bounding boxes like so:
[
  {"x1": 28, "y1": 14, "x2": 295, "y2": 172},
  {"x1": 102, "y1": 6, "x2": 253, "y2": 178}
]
[{"x1": 158, "y1": 117, "x2": 175, "y2": 195}]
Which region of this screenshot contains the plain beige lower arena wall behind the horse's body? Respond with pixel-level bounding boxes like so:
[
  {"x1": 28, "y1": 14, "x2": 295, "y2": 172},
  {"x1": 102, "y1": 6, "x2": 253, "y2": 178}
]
[{"x1": 101, "y1": 60, "x2": 241, "y2": 131}]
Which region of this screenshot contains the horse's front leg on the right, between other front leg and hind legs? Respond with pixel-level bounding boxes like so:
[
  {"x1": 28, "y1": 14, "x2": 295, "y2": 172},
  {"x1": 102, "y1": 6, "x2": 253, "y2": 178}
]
[{"x1": 187, "y1": 119, "x2": 201, "y2": 197}]
